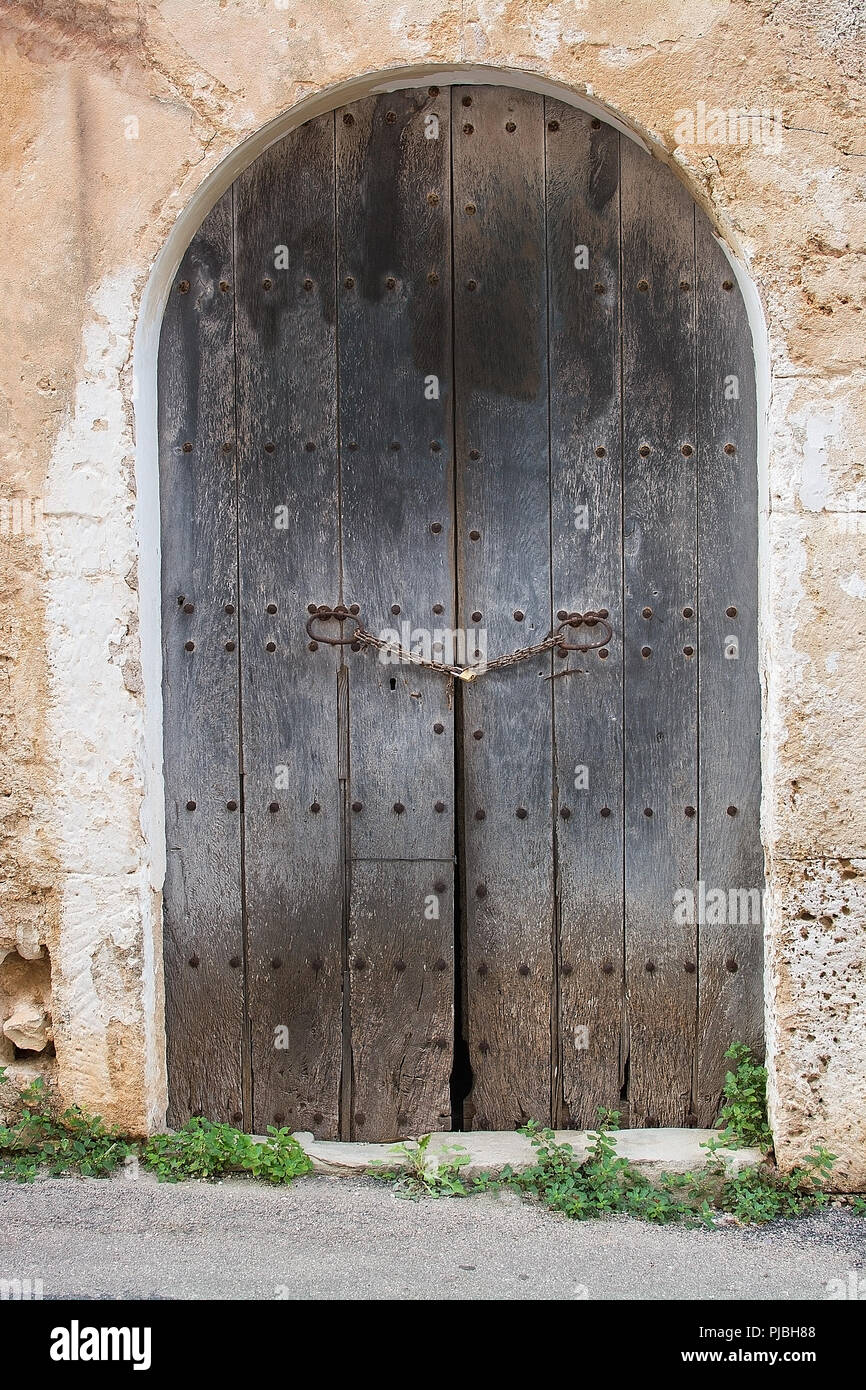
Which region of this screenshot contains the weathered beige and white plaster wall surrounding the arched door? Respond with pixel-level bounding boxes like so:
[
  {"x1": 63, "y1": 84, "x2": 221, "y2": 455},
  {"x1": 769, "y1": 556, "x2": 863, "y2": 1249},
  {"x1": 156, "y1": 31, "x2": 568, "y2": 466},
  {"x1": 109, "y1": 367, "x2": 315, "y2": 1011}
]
[{"x1": 0, "y1": 0, "x2": 866, "y2": 1187}]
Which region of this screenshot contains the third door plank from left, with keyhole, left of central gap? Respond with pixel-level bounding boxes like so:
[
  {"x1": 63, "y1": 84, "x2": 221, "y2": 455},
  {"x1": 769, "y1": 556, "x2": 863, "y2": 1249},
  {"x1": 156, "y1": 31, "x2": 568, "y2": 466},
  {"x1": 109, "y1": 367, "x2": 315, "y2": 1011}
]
[{"x1": 336, "y1": 88, "x2": 455, "y2": 1138}]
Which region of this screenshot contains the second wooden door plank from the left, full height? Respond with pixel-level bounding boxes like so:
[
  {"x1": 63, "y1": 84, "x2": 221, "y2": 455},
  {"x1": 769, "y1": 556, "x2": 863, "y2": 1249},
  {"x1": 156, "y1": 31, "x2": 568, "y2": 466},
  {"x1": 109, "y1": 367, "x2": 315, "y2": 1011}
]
[{"x1": 235, "y1": 115, "x2": 342, "y2": 1138}]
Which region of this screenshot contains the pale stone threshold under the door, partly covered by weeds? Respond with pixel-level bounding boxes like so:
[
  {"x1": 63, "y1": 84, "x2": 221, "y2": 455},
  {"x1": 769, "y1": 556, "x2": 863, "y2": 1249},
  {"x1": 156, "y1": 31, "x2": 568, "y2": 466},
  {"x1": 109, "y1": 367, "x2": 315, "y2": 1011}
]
[{"x1": 295, "y1": 1129, "x2": 763, "y2": 1179}]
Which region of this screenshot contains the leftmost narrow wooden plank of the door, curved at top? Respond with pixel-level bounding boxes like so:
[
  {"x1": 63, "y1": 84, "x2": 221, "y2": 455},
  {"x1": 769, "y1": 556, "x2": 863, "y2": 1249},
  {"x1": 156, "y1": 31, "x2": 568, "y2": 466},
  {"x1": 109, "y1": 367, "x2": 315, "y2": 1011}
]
[{"x1": 158, "y1": 190, "x2": 243, "y2": 1125}]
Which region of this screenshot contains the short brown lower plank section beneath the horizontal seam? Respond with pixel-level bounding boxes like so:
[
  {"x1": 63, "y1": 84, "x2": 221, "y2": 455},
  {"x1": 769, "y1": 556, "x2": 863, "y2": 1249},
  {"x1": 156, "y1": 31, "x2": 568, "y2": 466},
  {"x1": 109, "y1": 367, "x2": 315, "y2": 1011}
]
[{"x1": 349, "y1": 859, "x2": 455, "y2": 1140}]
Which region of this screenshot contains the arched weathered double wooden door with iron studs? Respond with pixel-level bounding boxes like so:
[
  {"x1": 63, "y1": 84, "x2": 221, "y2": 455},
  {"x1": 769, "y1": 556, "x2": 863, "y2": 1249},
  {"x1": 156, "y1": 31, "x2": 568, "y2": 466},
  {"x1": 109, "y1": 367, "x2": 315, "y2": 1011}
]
[{"x1": 160, "y1": 86, "x2": 762, "y2": 1138}]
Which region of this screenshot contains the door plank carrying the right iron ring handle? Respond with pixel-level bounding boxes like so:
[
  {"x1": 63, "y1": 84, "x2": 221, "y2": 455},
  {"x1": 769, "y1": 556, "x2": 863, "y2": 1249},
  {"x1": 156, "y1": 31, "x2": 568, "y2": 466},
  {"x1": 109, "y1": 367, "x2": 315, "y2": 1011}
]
[{"x1": 545, "y1": 100, "x2": 624, "y2": 1127}]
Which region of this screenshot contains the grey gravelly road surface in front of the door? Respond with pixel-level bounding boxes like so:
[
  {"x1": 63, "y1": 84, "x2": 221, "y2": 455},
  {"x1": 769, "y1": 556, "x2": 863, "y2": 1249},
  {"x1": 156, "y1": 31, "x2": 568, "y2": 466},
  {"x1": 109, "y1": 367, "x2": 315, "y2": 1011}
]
[{"x1": 0, "y1": 1175, "x2": 866, "y2": 1300}]
